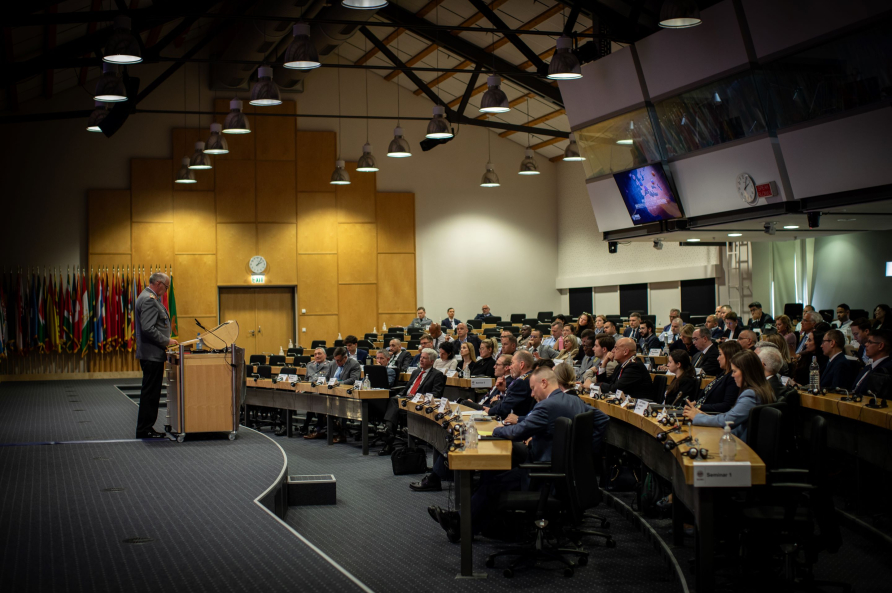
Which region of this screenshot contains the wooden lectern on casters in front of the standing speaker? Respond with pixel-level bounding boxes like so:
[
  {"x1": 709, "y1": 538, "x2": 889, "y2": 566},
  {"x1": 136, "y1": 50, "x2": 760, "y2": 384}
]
[{"x1": 165, "y1": 321, "x2": 245, "y2": 443}]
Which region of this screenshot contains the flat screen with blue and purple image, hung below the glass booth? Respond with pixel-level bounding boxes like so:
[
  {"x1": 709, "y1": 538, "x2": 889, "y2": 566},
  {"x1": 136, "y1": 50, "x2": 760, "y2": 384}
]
[{"x1": 613, "y1": 163, "x2": 684, "y2": 225}]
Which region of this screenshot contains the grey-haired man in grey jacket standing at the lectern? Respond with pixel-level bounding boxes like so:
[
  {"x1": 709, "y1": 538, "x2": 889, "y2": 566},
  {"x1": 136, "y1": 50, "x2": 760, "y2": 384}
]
[{"x1": 136, "y1": 272, "x2": 177, "y2": 439}]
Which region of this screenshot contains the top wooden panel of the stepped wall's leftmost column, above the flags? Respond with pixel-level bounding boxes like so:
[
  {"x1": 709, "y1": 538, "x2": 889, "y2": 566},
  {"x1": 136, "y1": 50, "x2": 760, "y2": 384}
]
[{"x1": 87, "y1": 189, "x2": 130, "y2": 254}]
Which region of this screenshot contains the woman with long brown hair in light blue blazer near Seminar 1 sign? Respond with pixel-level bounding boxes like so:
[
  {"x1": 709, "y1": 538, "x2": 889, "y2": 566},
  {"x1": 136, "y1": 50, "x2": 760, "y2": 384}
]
[{"x1": 684, "y1": 350, "x2": 775, "y2": 442}]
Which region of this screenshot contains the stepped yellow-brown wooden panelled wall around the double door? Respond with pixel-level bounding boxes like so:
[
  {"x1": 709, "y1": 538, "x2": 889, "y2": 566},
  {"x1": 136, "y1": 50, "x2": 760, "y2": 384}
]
[{"x1": 88, "y1": 100, "x2": 416, "y2": 346}]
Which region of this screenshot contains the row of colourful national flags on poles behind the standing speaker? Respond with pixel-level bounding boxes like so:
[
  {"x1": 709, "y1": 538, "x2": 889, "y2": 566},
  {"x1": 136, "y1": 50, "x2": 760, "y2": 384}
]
[{"x1": 0, "y1": 267, "x2": 177, "y2": 358}]
